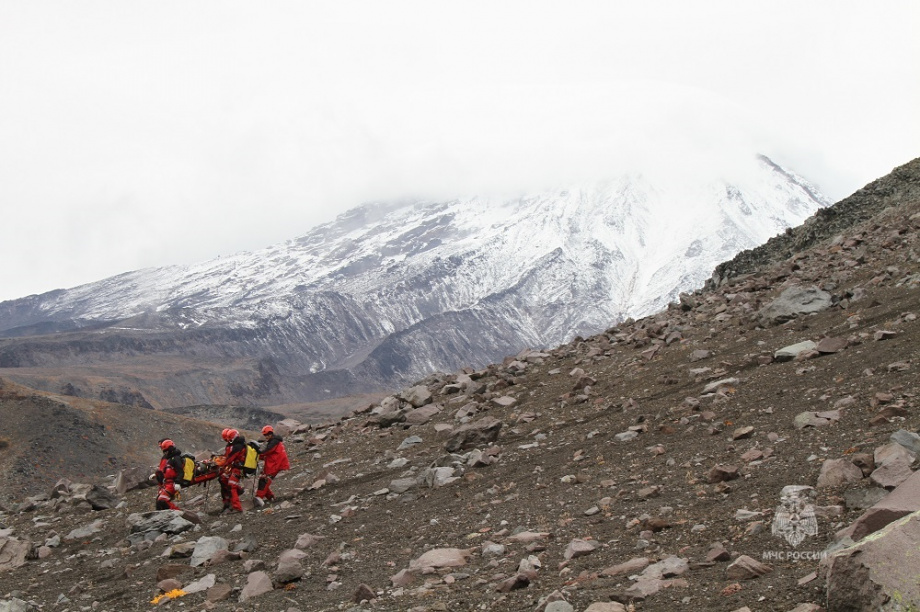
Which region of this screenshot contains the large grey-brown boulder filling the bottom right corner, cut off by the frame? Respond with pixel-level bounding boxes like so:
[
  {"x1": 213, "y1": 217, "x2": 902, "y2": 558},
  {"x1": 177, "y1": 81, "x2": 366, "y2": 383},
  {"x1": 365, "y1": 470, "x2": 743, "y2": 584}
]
[{"x1": 825, "y1": 512, "x2": 920, "y2": 612}]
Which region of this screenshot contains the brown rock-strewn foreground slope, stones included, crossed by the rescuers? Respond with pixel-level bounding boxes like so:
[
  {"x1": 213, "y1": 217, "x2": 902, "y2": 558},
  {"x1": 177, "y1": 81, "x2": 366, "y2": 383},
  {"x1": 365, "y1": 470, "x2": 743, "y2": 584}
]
[{"x1": 0, "y1": 159, "x2": 920, "y2": 612}]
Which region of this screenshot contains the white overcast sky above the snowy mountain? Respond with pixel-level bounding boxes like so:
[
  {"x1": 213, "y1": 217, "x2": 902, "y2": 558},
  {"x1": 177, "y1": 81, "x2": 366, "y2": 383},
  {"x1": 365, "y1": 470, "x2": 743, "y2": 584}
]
[{"x1": 0, "y1": 0, "x2": 920, "y2": 300}]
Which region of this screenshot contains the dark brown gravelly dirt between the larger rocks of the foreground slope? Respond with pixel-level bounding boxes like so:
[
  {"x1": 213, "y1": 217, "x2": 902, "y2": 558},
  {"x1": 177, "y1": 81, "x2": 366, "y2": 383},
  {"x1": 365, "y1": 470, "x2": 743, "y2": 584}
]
[{"x1": 0, "y1": 160, "x2": 920, "y2": 612}]
